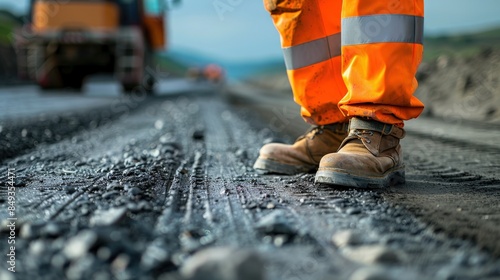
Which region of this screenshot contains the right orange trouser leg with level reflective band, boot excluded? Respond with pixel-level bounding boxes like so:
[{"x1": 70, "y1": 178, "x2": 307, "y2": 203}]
[{"x1": 339, "y1": 0, "x2": 424, "y2": 125}]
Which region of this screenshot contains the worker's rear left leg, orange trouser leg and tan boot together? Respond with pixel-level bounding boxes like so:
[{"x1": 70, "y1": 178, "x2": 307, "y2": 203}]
[{"x1": 254, "y1": 0, "x2": 347, "y2": 174}]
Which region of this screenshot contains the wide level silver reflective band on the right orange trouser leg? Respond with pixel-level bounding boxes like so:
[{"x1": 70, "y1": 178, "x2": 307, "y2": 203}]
[{"x1": 342, "y1": 14, "x2": 424, "y2": 46}]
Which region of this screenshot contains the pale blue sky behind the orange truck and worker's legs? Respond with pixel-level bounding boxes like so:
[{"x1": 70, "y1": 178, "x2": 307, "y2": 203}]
[{"x1": 0, "y1": 0, "x2": 500, "y2": 61}]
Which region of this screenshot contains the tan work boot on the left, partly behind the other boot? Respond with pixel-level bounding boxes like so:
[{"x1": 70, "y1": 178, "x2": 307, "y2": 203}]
[{"x1": 253, "y1": 123, "x2": 348, "y2": 175}]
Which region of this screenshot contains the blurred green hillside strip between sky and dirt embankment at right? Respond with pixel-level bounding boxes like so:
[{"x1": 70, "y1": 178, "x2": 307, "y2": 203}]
[{"x1": 424, "y1": 28, "x2": 500, "y2": 61}]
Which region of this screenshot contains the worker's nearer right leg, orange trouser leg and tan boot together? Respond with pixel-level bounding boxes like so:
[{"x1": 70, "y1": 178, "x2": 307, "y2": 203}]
[{"x1": 316, "y1": 0, "x2": 424, "y2": 187}]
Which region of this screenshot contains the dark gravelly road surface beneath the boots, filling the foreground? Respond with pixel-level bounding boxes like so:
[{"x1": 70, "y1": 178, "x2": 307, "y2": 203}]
[{"x1": 0, "y1": 83, "x2": 500, "y2": 280}]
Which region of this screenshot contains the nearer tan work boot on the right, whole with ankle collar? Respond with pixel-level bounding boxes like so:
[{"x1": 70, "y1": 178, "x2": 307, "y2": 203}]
[{"x1": 316, "y1": 118, "x2": 405, "y2": 188}]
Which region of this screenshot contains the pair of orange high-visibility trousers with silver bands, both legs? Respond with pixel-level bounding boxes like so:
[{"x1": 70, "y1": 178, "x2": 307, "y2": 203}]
[{"x1": 264, "y1": 0, "x2": 424, "y2": 125}]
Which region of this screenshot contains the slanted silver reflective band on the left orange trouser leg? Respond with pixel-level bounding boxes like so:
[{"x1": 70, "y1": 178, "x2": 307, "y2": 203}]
[{"x1": 283, "y1": 33, "x2": 341, "y2": 70}]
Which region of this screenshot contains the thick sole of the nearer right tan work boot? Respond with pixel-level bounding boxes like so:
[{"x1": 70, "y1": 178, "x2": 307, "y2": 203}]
[{"x1": 314, "y1": 166, "x2": 405, "y2": 189}]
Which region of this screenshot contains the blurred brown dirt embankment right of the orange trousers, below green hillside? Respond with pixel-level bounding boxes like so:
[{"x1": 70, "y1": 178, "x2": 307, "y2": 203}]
[{"x1": 416, "y1": 50, "x2": 500, "y2": 123}]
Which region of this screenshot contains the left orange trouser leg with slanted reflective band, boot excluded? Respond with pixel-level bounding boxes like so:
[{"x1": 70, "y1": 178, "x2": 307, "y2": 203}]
[{"x1": 264, "y1": 0, "x2": 347, "y2": 125}]
